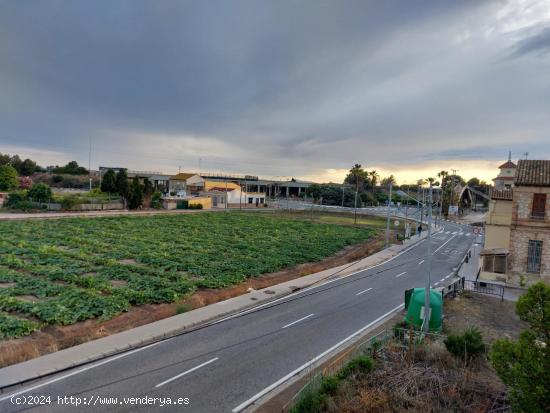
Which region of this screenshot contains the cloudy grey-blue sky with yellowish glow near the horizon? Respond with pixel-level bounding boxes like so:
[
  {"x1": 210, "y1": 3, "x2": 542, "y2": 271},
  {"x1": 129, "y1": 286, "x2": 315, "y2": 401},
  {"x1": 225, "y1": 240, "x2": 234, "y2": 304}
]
[{"x1": 0, "y1": 0, "x2": 550, "y2": 183}]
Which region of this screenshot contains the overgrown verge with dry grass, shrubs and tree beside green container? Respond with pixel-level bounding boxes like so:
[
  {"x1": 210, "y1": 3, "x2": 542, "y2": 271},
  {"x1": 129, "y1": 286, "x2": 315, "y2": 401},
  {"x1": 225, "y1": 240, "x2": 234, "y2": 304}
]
[{"x1": 290, "y1": 283, "x2": 550, "y2": 413}]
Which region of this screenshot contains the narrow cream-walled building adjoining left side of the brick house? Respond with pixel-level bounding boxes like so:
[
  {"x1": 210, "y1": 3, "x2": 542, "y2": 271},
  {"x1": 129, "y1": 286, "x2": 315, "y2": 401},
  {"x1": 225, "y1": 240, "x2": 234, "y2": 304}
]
[{"x1": 479, "y1": 188, "x2": 513, "y2": 282}]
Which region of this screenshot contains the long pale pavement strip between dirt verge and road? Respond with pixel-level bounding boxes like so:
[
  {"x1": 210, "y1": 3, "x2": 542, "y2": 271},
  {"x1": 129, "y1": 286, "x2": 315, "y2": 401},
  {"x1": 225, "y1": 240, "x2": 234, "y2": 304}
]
[{"x1": 0, "y1": 234, "x2": 432, "y2": 389}]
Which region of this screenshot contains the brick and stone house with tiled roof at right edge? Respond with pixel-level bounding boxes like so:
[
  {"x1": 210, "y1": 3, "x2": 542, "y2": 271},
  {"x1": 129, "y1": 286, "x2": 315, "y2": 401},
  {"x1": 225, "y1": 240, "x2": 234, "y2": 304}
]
[{"x1": 507, "y1": 160, "x2": 550, "y2": 283}]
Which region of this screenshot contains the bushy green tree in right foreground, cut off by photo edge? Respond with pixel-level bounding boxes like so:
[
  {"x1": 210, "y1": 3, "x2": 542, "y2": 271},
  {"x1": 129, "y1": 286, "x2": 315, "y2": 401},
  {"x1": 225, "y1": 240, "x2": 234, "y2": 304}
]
[{"x1": 490, "y1": 282, "x2": 550, "y2": 412}]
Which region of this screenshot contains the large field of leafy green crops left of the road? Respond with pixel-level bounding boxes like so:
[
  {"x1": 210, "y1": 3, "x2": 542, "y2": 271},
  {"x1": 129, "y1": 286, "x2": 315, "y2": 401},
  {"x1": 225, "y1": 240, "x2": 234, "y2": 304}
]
[{"x1": 0, "y1": 212, "x2": 376, "y2": 339}]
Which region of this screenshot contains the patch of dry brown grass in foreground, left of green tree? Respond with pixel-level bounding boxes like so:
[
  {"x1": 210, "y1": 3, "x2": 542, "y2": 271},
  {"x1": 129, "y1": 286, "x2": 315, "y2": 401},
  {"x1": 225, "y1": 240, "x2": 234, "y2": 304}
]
[{"x1": 326, "y1": 343, "x2": 505, "y2": 413}]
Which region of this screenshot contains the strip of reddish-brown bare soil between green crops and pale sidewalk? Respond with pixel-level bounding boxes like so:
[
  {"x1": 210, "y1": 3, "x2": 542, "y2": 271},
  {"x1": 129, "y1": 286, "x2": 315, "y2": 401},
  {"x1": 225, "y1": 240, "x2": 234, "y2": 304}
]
[{"x1": 0, "y1": 235, "x2": 392, "y2": 367}]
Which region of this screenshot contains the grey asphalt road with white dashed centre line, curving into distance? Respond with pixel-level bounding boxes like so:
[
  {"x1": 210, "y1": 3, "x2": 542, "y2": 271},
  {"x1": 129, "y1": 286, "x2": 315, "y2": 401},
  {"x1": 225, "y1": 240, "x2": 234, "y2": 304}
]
[{"x1": 0, "y1": 217, "x2": 474, "y2": 413}]
